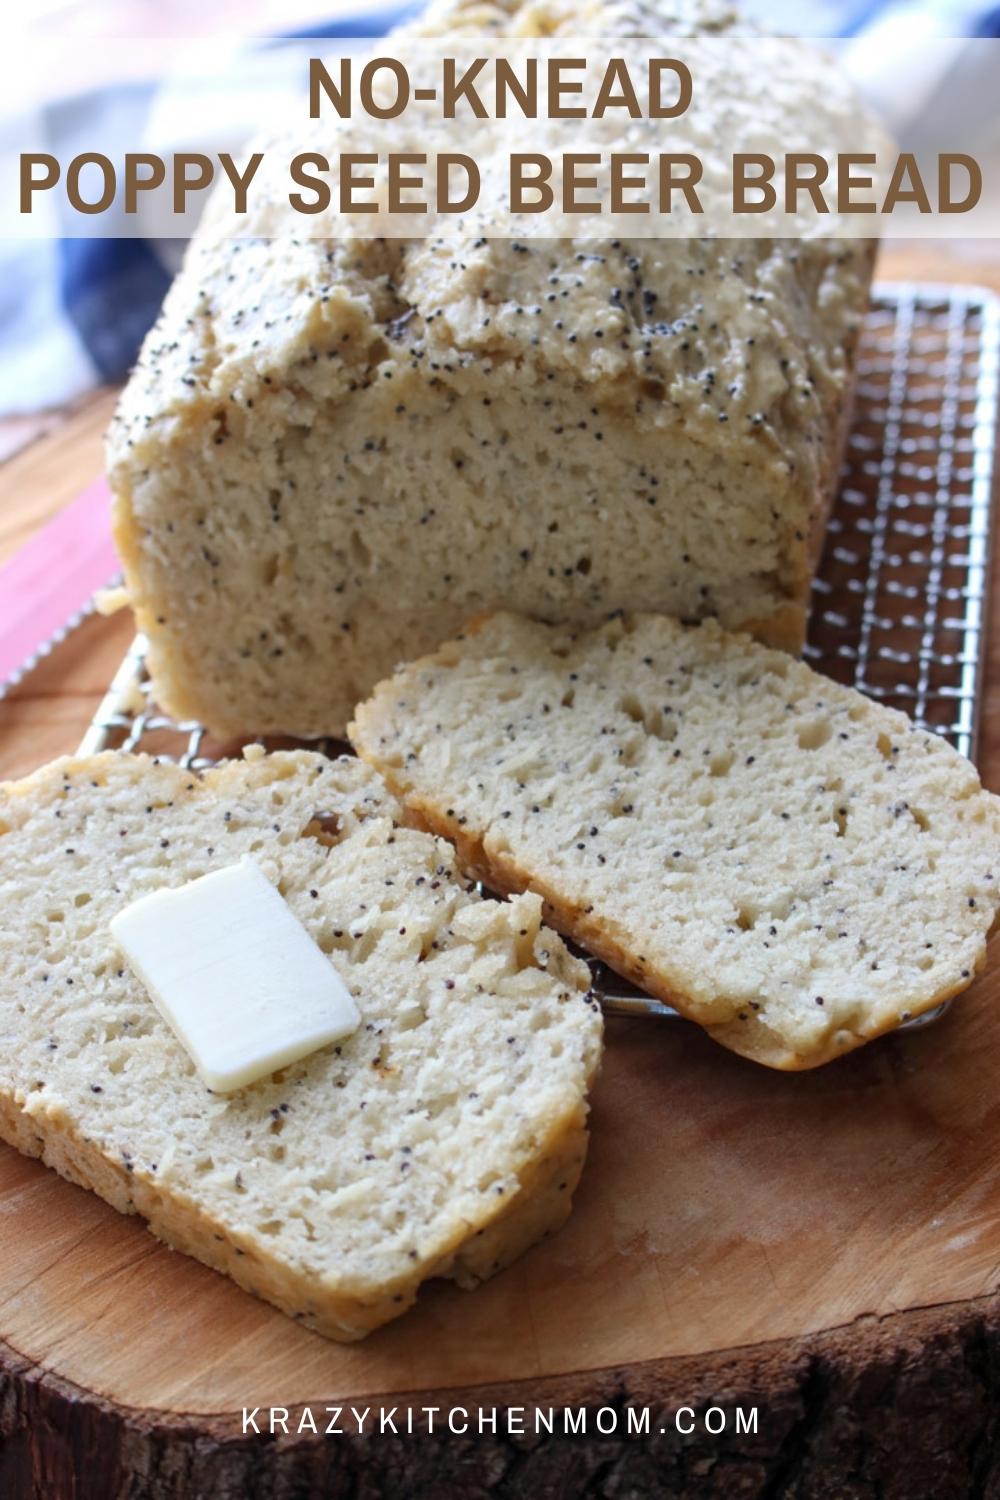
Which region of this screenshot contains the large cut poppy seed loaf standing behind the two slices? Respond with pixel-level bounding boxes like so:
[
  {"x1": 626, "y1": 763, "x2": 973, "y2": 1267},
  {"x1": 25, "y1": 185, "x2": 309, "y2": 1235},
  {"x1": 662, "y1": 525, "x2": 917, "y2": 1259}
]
[{"x1": 108, "y1": 0, "x2": 873, "y2": 735}]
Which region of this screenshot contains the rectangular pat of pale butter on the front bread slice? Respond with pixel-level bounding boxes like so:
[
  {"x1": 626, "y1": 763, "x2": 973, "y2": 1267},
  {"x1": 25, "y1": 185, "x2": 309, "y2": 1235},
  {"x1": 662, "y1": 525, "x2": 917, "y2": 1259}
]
[{"x1": 111, "y1": 860, "x2": 361, "y2": 1094}]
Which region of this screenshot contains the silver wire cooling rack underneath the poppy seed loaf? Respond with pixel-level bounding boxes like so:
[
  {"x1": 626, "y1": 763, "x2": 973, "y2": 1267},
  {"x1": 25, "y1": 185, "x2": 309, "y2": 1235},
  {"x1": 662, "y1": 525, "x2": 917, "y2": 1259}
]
[{"x1": 79, "y1": 285, "x2": 1000, "y2": 1029}]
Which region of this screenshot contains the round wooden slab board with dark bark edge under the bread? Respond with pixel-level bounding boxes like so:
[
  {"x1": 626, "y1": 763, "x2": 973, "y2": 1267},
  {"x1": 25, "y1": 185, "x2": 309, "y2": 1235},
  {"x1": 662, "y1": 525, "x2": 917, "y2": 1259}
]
[{"x1": 0, "y1": 258, "x2": 1000, "y2": 1500}]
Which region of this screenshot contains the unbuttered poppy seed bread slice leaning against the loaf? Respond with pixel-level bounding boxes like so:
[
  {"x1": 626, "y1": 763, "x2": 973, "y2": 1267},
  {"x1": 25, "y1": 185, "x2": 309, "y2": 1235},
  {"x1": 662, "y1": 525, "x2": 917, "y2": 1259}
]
[{"x1": 351, "y1": 614, "x2": 1000, "y2": 1068}]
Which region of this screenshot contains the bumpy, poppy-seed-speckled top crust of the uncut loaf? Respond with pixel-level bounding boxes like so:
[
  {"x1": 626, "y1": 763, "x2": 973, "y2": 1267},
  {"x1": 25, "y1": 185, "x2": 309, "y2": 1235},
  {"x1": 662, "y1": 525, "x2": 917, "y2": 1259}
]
[{"x1": 108, "y1": 0, "x2": 871, "y2": 510}]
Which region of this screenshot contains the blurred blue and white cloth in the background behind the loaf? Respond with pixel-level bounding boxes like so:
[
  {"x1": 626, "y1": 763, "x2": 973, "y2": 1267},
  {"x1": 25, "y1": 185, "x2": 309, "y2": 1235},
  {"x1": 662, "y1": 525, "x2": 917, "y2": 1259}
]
[{"x1": 0, "y1": 0, "x2": 1000, "y2": 416}]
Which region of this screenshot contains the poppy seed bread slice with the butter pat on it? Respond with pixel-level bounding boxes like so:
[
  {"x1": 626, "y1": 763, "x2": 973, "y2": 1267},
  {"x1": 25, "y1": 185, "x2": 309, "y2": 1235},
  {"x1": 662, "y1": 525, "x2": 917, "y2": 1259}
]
[{"x1": 0, "y1": 752, "x2": 601, "y2": 1340}]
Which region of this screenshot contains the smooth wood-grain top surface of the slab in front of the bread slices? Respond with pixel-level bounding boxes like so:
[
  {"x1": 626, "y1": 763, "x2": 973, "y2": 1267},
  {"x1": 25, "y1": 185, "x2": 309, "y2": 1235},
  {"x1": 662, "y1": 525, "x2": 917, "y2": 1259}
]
[{"x1": 0, "y1": 974, "x2": 1000, "y2": 1415}]
